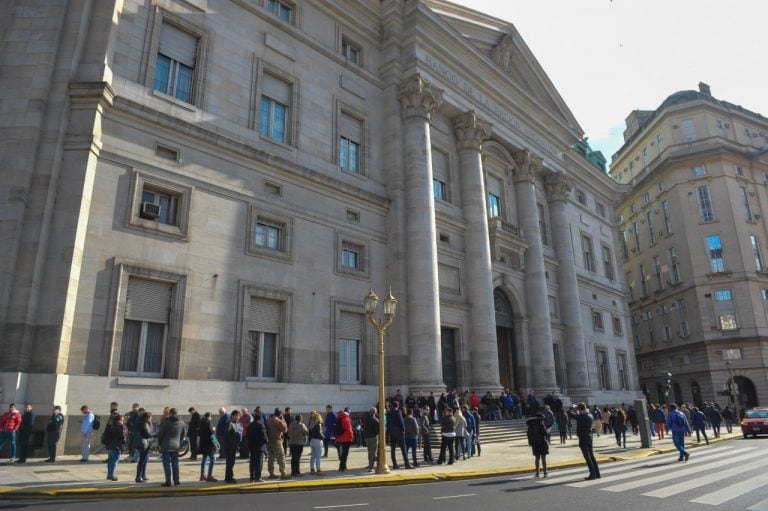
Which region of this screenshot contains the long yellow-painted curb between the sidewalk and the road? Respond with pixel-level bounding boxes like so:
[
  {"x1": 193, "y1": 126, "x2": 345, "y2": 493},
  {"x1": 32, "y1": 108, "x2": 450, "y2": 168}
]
[{"x1": 0, "y1": 436, "x2": 739, "y2": 500}]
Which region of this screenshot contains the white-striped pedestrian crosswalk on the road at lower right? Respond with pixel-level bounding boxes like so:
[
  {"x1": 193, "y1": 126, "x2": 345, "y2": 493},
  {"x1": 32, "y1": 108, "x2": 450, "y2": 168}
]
[{"x1": 536, "y1": 443, "x2": 768, "y2": 511}]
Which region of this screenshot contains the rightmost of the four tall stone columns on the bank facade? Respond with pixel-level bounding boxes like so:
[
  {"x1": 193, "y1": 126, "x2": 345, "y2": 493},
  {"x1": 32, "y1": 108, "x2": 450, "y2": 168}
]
[{"x1": 544, "y1": 172, "x2": 592, "y2": 401}]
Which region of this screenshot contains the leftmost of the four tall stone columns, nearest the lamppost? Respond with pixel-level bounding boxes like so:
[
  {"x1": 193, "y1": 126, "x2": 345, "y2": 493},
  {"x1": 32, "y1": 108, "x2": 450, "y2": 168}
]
[{"x1": 400, "y1": 74, "x2": 445, "y2": 391}]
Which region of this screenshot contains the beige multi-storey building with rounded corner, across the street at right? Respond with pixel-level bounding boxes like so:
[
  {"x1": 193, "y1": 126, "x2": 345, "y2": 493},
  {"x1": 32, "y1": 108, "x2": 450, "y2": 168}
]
[{"x1": 611, "y1": 83, "x2": 768, "y2": 412}]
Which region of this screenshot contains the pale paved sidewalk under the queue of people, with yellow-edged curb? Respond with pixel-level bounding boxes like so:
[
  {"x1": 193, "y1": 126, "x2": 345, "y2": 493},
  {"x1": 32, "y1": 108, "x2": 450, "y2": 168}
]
[{"x1": 0, "y1": 429, "x2": 741, "y2": 500}]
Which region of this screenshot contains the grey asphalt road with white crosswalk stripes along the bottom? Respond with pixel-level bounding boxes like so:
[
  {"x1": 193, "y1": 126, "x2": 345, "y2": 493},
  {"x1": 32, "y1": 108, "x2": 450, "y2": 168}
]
[{"x1": 0, "y1": 439, "x2": 768, "y2": 511}]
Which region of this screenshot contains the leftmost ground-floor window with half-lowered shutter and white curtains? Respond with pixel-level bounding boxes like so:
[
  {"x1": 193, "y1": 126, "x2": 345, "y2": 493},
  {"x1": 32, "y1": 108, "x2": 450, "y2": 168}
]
[{"x1": 119, "y1": 277, "x2": 173, "y2": 377}]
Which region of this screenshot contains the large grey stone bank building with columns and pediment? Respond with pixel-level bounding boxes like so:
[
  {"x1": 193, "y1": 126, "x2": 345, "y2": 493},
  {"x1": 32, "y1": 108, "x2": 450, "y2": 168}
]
[{"x1": 0, "y1": 0, "x2": 639, "y2": 452}]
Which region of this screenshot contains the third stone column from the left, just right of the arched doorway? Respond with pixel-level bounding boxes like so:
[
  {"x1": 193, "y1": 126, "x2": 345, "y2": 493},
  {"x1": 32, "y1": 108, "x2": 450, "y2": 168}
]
[{"x1": 513, "y1": 149, "x2": 557, "y2": 394}]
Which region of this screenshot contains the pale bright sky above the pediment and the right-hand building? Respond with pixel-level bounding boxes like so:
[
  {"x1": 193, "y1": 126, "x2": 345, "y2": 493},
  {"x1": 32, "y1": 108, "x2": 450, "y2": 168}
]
[{"x1": 452, "y1": 0, "x2": 768, "y2": 170}]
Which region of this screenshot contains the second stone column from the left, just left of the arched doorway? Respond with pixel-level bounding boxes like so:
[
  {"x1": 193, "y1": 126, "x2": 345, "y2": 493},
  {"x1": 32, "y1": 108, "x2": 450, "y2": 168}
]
[{"x1": 453, "y1": 112, "x2": 501, "y2": 393}]
